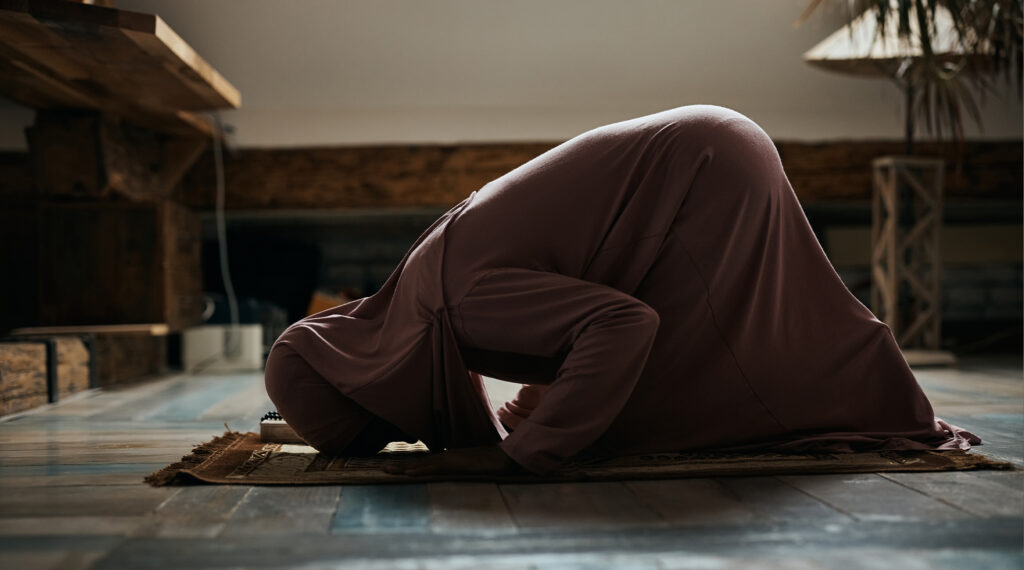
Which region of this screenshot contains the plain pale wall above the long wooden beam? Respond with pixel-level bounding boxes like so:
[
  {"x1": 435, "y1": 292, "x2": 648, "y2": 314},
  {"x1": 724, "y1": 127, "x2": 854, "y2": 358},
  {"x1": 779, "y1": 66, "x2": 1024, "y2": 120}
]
[{"x1": 0, "y1": 0, "x2": 1022, "y2": 148}]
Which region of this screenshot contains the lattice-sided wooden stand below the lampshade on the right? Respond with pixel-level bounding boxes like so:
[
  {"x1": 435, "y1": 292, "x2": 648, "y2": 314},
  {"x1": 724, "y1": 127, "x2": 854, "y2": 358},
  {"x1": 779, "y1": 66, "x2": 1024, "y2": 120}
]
[{"x1": 871, "y1": 157, "x2": 954, "y2": 364}]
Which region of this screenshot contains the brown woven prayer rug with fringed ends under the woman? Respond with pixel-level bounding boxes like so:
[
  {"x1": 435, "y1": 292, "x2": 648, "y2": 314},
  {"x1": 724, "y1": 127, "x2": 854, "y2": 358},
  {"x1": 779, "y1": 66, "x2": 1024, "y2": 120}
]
[{"x1": 145, "y1": 431, "x2": 1016, "y2": 486}]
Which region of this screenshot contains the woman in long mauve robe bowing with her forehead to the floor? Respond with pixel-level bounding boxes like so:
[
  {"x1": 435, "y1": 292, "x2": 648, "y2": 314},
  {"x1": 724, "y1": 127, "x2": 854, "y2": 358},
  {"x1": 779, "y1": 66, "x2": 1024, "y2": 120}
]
[{"x1": 266, "y1": 105, "x2": 980, "y2": 475}]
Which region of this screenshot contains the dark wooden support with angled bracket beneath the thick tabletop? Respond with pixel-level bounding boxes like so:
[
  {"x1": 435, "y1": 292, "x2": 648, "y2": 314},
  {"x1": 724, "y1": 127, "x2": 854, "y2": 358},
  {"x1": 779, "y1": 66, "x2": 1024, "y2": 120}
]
[{"x1": 28, "y1": 109, "x2": 208, "y2": 331}]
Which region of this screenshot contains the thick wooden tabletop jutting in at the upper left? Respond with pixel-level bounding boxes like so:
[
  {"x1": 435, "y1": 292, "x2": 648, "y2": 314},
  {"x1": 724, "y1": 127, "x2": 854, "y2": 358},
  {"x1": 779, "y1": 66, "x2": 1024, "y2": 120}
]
[{"x1": 0, "y1": 0, "x2": 242, "y2": 134}]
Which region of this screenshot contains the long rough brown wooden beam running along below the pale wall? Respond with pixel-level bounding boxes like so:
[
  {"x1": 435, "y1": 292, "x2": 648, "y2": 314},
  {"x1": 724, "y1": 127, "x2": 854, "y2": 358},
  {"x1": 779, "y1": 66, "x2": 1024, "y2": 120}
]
[{"x1": 179, "y1": 140, "x2": 1024, "y2": 210}]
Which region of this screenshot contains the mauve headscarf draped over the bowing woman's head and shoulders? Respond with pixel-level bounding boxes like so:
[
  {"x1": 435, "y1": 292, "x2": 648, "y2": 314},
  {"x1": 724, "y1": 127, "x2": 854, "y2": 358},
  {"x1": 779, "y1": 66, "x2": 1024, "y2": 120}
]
[{"x1": 267, "y1": 192, "x2": 506, "y2": 449}]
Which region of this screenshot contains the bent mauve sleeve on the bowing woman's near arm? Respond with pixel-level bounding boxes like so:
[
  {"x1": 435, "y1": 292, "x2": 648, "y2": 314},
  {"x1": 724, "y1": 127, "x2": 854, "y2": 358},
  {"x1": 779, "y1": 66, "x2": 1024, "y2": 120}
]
[{"x1": 453, "y1": 268, "x2": 659, "y2": 474}]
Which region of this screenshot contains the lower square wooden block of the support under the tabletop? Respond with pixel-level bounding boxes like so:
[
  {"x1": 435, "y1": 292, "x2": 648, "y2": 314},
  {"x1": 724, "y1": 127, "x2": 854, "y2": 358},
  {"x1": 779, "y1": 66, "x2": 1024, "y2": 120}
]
[{"x1": 36, "y1": 202, "x2": 203, "y2": 332}]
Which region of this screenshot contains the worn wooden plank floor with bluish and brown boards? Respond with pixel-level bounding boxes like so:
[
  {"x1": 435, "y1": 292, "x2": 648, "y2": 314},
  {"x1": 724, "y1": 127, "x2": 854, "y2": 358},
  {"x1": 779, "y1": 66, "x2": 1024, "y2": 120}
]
[{"x1": 0, "y1": 356, "x2": 1024, "y2": 570}]
